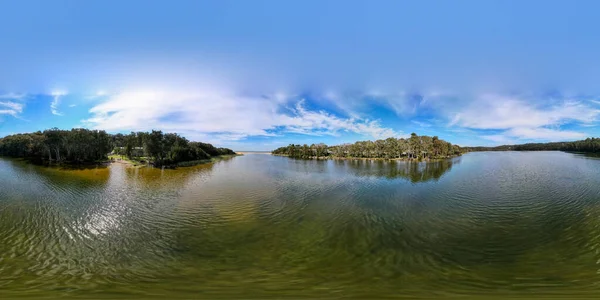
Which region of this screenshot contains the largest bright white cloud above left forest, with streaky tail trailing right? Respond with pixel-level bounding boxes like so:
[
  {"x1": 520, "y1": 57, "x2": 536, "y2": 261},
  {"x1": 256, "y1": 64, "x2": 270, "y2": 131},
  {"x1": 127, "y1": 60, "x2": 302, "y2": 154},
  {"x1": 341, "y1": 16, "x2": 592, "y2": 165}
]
[{"x1": 83, "y1": 91, "x2": 397, "y2": 141}]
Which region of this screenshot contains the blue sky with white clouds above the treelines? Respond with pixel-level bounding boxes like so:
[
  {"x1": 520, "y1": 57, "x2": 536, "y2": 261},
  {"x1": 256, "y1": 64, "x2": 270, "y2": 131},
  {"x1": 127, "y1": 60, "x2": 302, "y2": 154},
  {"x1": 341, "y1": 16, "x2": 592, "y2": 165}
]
[{"x1": 0, "y1": 0, "x2": 600, "y2": 150}]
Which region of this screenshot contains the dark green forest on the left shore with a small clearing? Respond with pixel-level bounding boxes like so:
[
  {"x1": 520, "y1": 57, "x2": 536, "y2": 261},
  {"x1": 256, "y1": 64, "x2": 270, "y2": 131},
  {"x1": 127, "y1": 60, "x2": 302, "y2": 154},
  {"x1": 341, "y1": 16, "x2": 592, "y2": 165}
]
[{"x1": 0, "y1": 128, "x2": 235, "y2": 166}]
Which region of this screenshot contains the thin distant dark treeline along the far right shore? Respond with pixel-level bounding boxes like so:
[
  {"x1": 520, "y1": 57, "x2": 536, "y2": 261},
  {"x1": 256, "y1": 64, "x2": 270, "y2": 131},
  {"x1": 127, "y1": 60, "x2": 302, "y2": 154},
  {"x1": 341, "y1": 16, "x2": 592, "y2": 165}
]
[{"x1": 464, "y1": 138, "x2": 600, "y2": 153}]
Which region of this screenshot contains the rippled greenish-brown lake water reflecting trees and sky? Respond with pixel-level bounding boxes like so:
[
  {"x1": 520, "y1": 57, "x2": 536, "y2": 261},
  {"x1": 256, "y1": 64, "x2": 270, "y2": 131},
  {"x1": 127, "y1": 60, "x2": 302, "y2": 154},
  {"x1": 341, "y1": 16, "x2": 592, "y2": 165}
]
[{"x1": 0, "y1": 152, "x2": 600, "y2": 299}]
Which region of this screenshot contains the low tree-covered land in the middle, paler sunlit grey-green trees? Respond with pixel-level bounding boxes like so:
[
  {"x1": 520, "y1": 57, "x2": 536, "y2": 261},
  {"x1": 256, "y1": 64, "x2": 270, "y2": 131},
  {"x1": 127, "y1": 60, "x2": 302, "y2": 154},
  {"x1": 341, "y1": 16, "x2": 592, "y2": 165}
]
[{"x1": 271, "y1": 133, "x2": 462, "y2": 159}]
